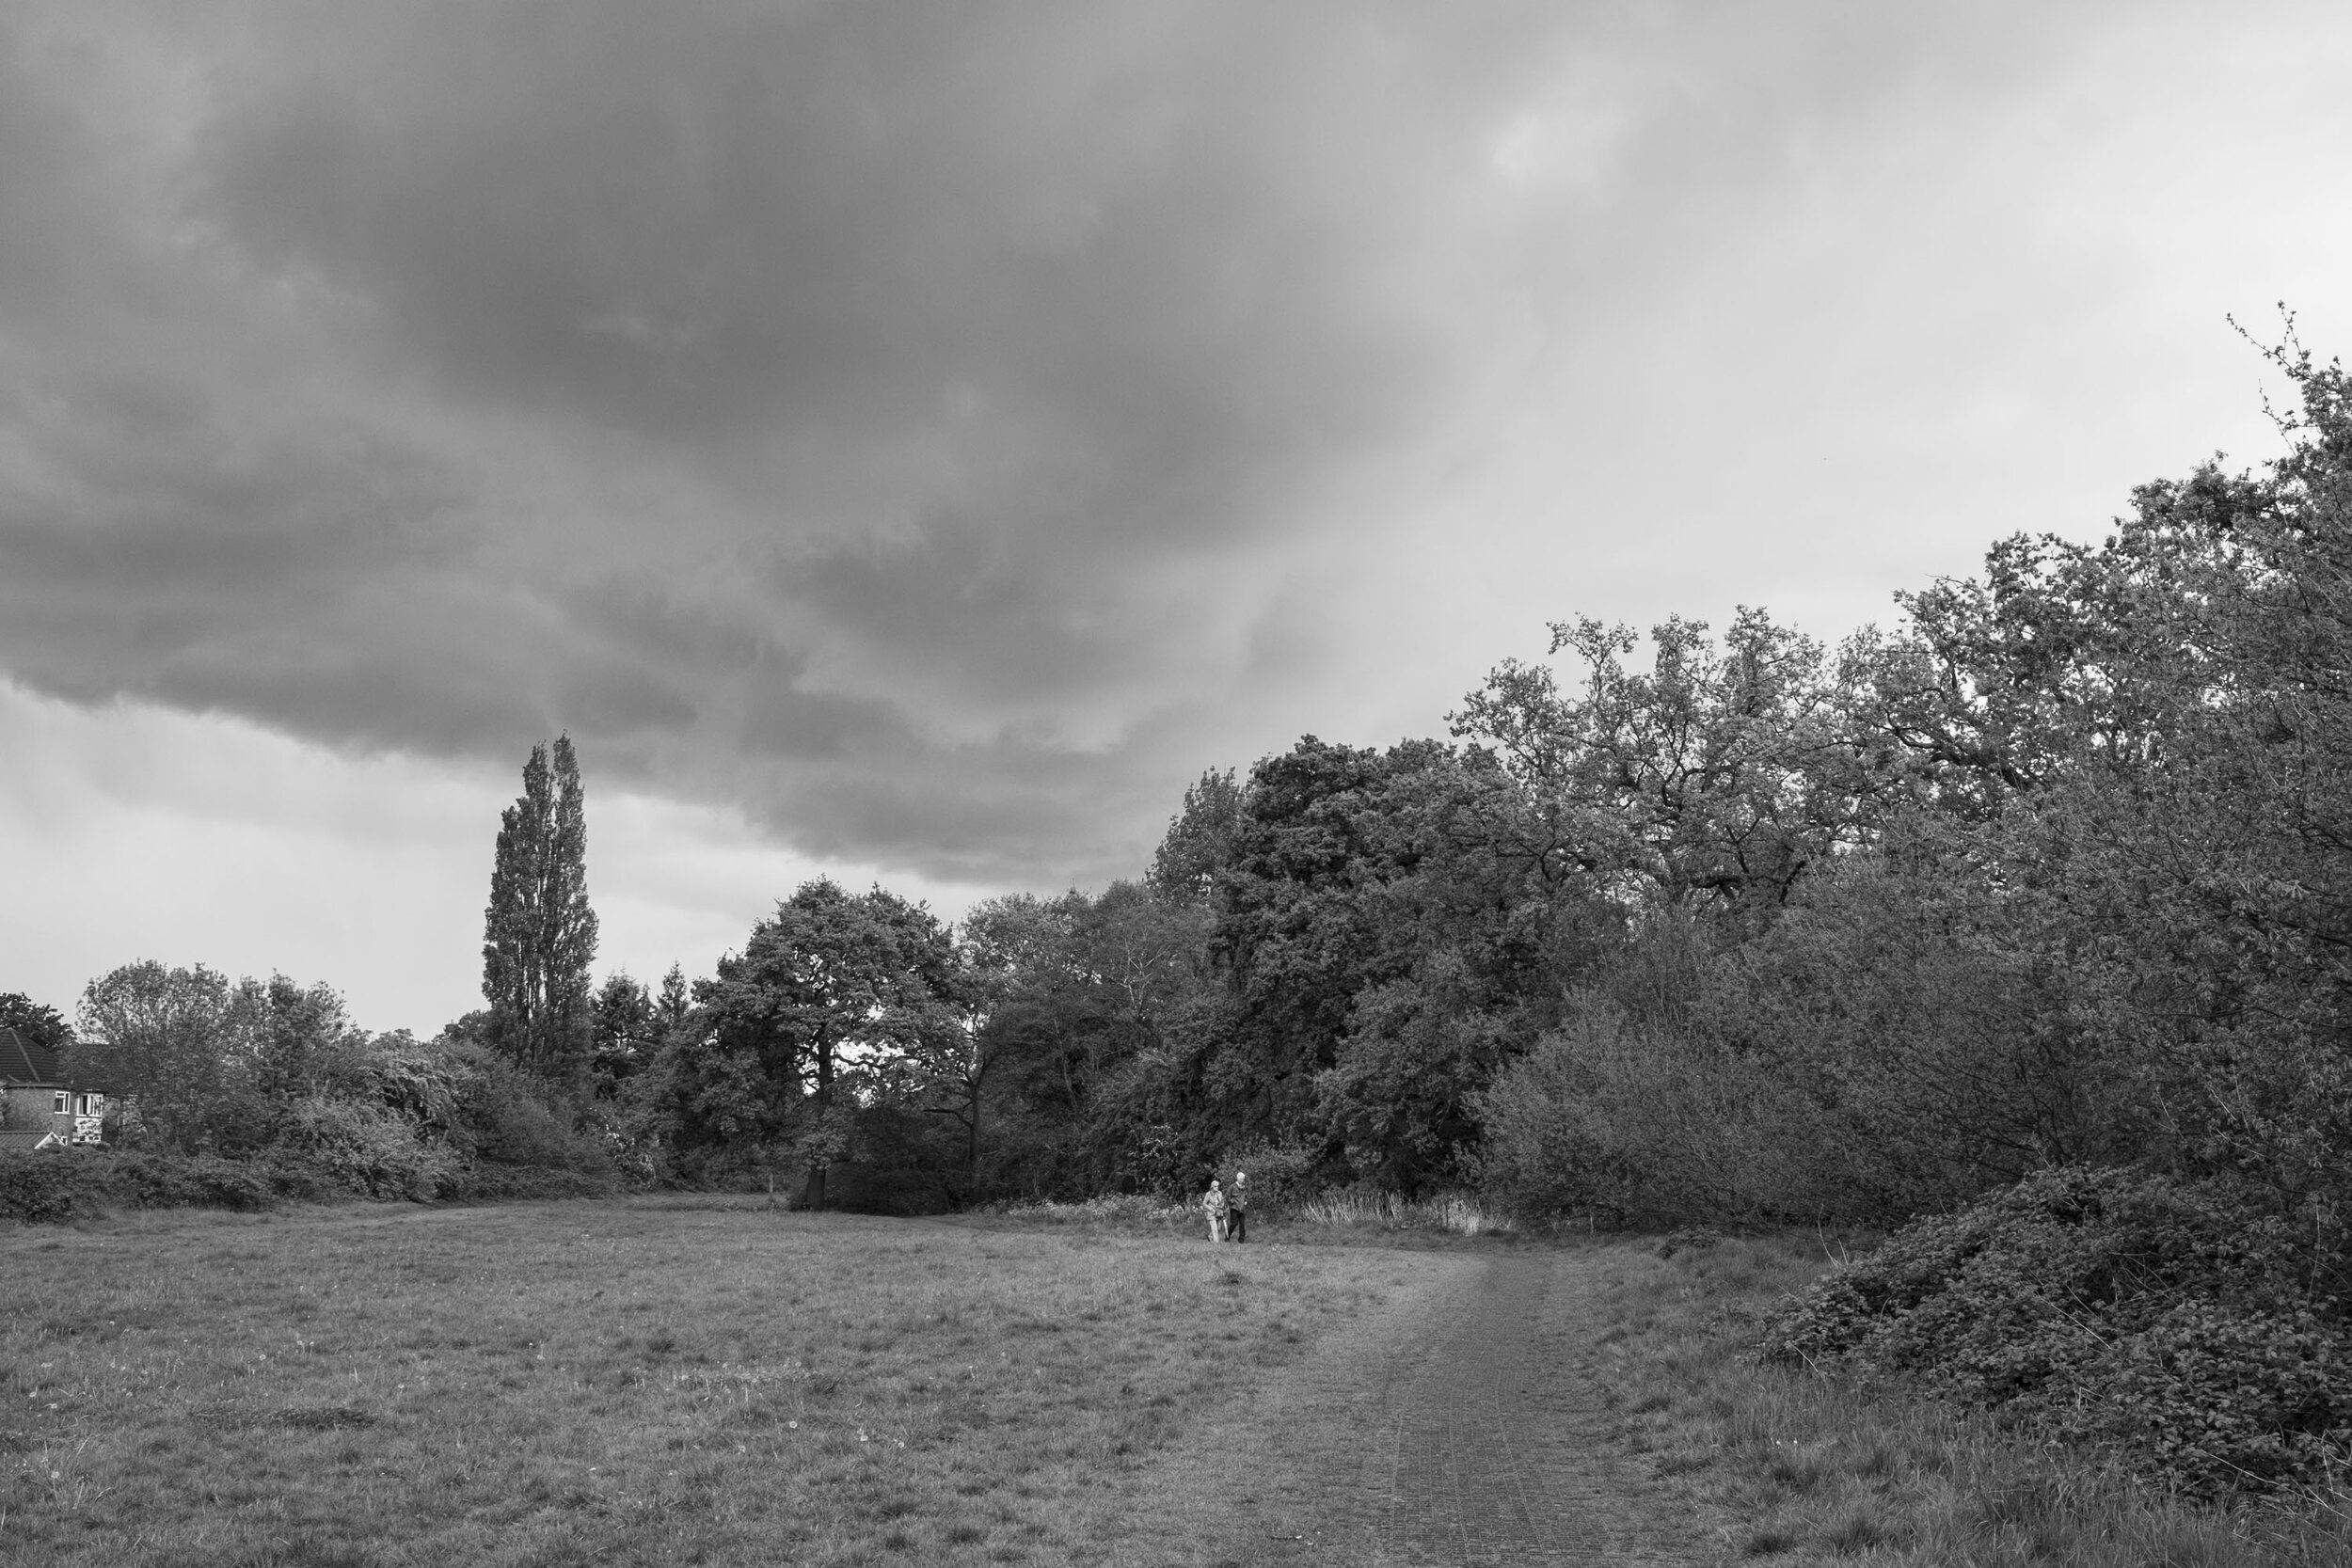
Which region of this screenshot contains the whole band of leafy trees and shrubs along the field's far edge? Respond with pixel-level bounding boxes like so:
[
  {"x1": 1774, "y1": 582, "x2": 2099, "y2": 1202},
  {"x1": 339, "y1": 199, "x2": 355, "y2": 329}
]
[{"x1": 8, "y1": 348, "x2": 2352, "y2": 1234}]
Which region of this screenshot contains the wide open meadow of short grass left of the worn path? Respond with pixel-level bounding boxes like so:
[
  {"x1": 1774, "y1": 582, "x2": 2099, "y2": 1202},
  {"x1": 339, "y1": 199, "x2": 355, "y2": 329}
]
[{"x1": 0, "y1": 1201, "x2": 1433, "y2": 1568}]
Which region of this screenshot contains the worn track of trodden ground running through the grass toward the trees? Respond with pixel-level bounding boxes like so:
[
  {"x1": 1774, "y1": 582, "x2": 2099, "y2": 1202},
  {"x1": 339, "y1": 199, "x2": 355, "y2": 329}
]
[{"x1": 1118, "y1": 1251, "x2": 1710, "y2": 1568}]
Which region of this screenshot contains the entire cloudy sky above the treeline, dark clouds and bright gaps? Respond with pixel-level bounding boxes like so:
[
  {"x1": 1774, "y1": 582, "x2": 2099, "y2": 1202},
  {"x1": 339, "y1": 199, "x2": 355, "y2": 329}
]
[{"x1": 0, "y1": 0, "x2": 2352, "y2": 1032}]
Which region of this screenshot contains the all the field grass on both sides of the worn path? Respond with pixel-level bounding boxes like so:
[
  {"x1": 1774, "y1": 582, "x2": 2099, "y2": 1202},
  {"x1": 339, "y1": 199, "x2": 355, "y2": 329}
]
[{"x1": 13, "y1": 1199, "x2": 2352, "y2": 1568}]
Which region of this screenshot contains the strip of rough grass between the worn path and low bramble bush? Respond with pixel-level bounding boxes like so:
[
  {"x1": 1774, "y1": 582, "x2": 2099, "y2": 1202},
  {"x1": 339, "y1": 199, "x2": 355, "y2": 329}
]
[{"x1": 1593, "y1": 1234, "x2": 2352, "y2": 1568}]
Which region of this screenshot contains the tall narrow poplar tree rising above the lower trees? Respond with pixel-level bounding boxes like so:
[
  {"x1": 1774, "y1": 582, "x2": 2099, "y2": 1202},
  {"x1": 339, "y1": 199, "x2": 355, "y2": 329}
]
[{"x1": 483, "y1": 736, "x2": 596, "y2": 1086}]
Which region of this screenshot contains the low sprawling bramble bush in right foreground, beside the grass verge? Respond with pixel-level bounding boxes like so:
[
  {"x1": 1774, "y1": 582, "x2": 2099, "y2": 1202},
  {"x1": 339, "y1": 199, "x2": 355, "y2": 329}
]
[{"x1": 1762, "y1": 1166, "x2": 2352, "y2": 1497}]
